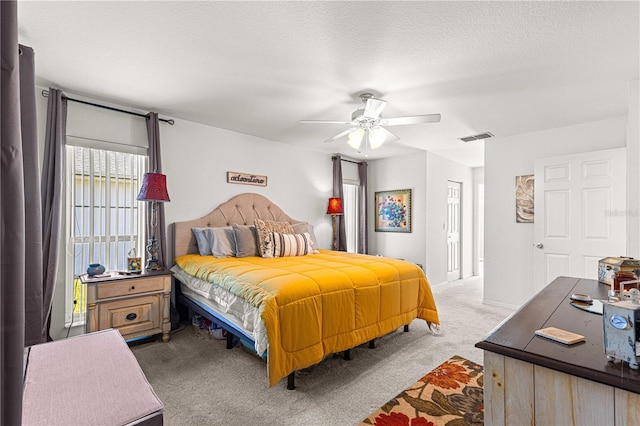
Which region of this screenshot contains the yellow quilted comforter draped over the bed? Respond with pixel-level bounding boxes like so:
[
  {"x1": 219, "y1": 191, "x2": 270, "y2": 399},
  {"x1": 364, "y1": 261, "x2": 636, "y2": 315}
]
[{"x1": 176, "y1": 250, "x2": 439, "y2": 386}]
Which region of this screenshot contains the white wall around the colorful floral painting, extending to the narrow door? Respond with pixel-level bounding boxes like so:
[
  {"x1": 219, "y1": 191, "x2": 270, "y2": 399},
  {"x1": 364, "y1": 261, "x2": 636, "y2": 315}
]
[{"x1": 369, "y1": 152, "x2": 473, "y2": 285}]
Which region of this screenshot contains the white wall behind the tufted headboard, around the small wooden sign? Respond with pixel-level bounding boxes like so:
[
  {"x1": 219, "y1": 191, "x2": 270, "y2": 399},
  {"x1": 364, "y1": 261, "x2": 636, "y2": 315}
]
[{"x1": 160, "y1": 115, "x2": 333, "y2": 260}]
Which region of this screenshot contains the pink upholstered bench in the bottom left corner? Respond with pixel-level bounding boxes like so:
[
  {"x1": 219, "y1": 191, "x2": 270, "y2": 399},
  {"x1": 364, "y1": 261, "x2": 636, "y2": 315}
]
[{"x1": 22, "y1": 329, "x2": 164, "y2": 426}]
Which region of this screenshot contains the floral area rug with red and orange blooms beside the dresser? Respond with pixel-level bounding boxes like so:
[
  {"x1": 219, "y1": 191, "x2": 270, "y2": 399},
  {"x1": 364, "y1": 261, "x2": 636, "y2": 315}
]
[{"x1": 360, "y1": 355, "x2": 484, "y2": 426}]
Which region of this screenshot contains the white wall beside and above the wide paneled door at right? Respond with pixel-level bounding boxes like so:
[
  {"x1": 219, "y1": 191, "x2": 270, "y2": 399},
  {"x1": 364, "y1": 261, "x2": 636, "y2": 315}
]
[{"x1": 484, "y1": 117, "x2": 627, "y2": 308}]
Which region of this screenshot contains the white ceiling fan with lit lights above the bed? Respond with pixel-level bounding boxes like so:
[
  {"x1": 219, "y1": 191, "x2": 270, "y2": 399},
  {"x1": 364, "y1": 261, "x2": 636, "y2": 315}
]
[{"x1": 301, "y1": 93, "x2": 440, "y2": 153}]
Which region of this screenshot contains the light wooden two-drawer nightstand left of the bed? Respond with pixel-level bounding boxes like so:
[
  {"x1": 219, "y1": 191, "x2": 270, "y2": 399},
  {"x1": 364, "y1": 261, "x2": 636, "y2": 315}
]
[{"x1": 80, "y1": 270, "x2": 172, "y2": 342}]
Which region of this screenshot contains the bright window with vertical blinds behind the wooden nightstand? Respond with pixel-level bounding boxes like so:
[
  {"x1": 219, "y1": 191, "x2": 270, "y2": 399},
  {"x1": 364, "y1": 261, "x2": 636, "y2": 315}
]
[{"x1": 65, "y1": 145, "x2": 147, "y2": 327}]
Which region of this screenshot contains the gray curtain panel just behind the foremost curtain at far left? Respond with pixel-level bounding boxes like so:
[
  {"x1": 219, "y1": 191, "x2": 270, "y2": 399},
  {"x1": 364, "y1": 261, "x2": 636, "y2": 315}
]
[{"x1": 20, "y1": 46, "x2": 46, "y2": 346}]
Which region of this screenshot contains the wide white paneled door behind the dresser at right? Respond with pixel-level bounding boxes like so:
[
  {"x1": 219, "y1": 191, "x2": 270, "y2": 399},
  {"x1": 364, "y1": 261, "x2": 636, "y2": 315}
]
[{"x1": 533, "y1": 148, "x2": 627, "y2": 292}]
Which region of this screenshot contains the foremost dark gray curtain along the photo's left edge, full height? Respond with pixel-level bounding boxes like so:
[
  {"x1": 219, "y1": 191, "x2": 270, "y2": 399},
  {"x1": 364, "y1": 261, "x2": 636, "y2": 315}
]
[{"x1": 0, "y1": 1, "x2": 33, "y2": 425}]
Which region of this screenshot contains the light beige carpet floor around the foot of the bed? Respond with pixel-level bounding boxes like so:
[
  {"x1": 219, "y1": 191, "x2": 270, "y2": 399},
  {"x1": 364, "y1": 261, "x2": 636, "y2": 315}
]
[{"x1": 131, "y1": 277, "x2": 512, "y2": 426}]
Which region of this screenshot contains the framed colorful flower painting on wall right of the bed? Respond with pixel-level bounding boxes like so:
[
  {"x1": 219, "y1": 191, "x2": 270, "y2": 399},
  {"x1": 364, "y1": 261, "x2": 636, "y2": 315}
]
[{"x1": 374, "y1": 189, "x2": 411, "y2": 232}]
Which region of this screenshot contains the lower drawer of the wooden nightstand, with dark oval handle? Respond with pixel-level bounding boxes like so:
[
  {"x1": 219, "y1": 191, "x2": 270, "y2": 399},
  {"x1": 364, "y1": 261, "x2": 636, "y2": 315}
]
[{"x1": 98, "y1": 294, "x2": 162, "y2": 338}]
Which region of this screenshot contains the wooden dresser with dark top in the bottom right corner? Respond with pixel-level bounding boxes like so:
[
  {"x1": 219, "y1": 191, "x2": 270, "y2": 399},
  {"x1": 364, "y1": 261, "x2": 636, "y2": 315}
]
[{"x1": 476, "y1": 277, "x2": 640, "y2": 425}]
